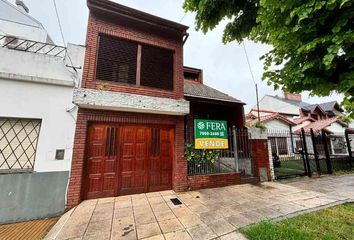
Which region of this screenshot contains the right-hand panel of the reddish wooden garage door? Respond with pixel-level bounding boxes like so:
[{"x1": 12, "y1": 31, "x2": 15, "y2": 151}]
[{"x1": 149, "y1": 128, "x2": 174, "y2": 191}]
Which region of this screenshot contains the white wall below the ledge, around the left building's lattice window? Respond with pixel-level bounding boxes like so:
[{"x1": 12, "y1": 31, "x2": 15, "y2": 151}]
[{"x1": 0, "y1": 79, "x2": 76, "y2": 172}]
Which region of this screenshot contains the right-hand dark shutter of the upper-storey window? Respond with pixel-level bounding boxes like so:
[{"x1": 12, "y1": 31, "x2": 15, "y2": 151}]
[{"x1": 140, "y1": 45, "x2": 174, "y2": 90}]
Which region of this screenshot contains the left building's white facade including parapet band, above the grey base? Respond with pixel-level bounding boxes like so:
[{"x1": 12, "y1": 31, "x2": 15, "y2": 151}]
[{"x1": 0, "y1": 45, "x2": 85, "y2": 172}]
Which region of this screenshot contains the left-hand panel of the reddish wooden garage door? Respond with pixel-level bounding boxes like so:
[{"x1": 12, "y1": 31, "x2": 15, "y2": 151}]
[{"x1": 84, "y1": 124, "x2": 118, "y2": 199}]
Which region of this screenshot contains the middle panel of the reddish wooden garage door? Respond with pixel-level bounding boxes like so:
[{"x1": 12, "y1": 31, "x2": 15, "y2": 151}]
[{"x1": 118, "y1": 126, "x2": 148, "y2": 195}]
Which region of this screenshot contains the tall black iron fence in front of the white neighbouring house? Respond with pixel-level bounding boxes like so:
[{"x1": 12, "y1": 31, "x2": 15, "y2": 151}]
[{"x1": 268, "y1": 126, "x2": 354, "y2": 179}]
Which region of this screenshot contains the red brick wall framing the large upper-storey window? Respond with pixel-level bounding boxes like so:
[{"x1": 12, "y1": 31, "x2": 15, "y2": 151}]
[{"x1": 81, "y1": 13, "x2": 184, "y2": 99}]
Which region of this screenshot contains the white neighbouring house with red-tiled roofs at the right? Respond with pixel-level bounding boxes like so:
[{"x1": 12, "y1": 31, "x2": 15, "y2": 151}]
[{"x1": 246, "y1": 93, "x2": 348, "y2": 155}]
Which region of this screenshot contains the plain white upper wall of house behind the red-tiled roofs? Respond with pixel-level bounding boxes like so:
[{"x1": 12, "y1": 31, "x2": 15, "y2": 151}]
[{"x1": 259, "y1": 95, "x2": 299, "y2": 115}]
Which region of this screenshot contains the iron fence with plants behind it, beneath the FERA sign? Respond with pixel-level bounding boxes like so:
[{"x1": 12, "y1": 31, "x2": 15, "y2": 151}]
[{"x1": 185, "y1": 126, "x2": 253, "y2": 176}]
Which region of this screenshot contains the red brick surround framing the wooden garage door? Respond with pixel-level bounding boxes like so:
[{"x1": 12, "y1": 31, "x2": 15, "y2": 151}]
[{"x1": 67, "y1": 109, "x2": 187, "y2": 208}]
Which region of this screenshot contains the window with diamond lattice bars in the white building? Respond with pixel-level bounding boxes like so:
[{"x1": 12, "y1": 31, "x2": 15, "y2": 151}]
[{"x1": 0, "y1": 118, "x2": 41, "y2": 171}]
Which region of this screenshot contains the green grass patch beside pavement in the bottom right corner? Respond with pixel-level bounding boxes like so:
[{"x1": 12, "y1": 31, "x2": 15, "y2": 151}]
[{"x1": 240, "y1": 203, "x2": 354, "y2": 240}]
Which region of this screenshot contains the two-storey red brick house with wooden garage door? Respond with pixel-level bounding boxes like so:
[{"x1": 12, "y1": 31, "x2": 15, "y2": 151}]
[{"x1": 67, "y1": 0, "x2": 269, "y2": 208}]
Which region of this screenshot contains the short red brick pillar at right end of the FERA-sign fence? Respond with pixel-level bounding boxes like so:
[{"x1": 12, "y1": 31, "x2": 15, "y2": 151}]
[{"x1": 251, "y1": 139, "x2": 271, "y2": 181}]
